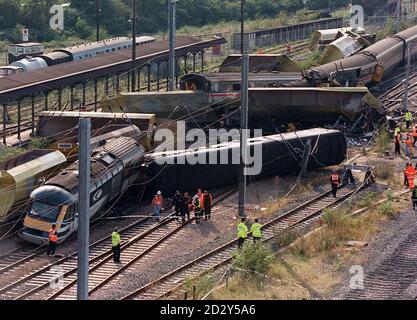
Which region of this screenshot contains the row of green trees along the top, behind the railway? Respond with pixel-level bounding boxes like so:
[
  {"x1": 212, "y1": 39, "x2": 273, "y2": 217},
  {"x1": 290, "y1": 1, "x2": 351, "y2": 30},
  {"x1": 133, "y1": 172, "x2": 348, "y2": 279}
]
[{"x1": 0, "y1": 0, "x2": 351, "y2": 41}]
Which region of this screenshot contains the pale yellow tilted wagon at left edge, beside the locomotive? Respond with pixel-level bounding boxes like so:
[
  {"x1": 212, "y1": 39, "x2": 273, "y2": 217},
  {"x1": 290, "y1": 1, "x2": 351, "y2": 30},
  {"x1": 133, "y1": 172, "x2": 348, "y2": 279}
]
[{"x1": 0, "y1": 150, "x2": 67, "y2": 221}]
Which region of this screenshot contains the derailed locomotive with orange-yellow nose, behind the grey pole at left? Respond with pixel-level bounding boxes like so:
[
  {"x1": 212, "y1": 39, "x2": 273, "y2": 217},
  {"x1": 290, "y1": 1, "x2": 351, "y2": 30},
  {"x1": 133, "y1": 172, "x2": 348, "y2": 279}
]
[{"x1": 20, "y1": 137, "x2": 145, "y2": 245}]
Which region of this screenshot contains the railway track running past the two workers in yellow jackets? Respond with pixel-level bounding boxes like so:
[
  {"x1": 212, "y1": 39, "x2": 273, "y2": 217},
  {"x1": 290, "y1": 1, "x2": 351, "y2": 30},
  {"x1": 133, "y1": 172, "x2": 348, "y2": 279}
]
[{"x1": 123, "y1": 186, "x2": 363, "y2": 300}]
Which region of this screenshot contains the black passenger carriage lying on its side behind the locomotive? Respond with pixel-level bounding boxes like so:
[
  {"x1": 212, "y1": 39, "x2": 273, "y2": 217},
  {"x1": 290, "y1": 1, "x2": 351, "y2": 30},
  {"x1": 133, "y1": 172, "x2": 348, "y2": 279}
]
[{"x1": 143, "y1": 129, "x2": 346, "y2": 196}]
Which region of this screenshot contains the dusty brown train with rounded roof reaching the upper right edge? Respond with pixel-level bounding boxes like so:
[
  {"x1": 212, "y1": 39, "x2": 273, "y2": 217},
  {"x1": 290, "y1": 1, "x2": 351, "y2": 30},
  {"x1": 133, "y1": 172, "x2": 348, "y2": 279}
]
[{"x1": 306, "y1": 26, "x2": 417, "y2": 86}]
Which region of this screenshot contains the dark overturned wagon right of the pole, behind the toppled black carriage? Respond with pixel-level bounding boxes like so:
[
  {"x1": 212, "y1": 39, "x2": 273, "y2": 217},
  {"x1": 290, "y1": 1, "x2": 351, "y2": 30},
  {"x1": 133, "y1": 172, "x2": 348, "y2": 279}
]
[{"x1": 237, "y1": 87, "x2": 384, "y2": 124}]
